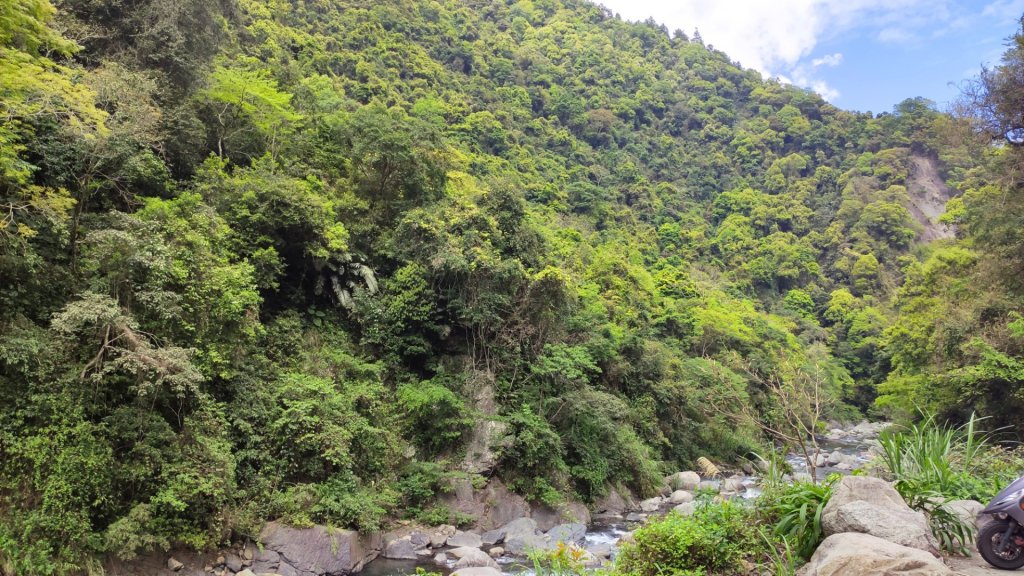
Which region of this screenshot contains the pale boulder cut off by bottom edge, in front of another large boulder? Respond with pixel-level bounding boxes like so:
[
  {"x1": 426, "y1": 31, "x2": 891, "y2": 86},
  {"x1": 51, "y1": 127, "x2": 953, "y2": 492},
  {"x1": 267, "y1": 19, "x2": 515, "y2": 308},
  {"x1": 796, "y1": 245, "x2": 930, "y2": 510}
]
[{"x1": 797, "y1": 532, "x2": 953, "y2": 576}]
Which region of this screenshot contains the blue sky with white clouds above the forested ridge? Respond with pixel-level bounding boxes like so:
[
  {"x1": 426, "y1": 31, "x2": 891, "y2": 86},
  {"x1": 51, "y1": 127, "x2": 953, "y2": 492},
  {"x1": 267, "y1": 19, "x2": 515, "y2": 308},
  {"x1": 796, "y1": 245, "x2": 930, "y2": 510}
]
[{"x1": 596, "y1": 0, "x2": 1024, "y2": 114}]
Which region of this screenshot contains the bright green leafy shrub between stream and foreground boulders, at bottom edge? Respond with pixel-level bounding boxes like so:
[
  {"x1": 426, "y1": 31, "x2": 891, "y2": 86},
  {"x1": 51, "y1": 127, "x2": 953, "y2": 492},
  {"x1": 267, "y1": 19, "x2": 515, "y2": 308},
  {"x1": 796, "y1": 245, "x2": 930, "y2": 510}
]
[{"x1": 615, "y1": 501, "x2": 763, "y2": 576}]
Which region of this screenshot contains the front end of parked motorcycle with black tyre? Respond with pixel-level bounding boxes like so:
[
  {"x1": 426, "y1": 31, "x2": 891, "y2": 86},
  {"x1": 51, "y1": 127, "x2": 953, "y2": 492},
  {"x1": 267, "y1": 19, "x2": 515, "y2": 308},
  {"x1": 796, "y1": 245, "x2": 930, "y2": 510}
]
[{"x1": 978, "y1": 476, "x2": 1024, "y2": 570}]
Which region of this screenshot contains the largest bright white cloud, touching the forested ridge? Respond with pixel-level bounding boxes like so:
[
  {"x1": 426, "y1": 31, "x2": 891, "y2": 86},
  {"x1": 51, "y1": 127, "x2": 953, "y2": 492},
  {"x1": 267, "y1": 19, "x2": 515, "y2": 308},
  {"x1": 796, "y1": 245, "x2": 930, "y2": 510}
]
[{"x1": 596, "y1": 0, "x2": 962, "y2": 99}]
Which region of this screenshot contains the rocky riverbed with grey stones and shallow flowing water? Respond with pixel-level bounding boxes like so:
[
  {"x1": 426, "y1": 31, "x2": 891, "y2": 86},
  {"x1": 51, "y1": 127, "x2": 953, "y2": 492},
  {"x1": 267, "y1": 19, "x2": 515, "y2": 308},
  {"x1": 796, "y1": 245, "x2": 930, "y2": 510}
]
[{"x1": 108, "y1": 416, "x2": 886, "y2": 576}]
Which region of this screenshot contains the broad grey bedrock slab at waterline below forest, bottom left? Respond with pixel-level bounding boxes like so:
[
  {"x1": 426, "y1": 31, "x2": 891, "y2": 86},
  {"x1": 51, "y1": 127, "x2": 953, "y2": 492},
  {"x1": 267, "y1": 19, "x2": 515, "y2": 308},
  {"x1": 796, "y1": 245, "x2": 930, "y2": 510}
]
[{"x1": 257, "y1": 522, "x2": 383, "y2": 576}]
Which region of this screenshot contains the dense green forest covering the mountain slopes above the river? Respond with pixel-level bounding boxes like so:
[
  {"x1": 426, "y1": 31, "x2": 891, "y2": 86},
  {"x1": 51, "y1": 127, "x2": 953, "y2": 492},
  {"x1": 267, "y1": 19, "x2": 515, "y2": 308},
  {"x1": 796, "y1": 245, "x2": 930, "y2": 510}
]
[{"x1": 0, "y1": 0, "x2": 1024, "y2": 573}]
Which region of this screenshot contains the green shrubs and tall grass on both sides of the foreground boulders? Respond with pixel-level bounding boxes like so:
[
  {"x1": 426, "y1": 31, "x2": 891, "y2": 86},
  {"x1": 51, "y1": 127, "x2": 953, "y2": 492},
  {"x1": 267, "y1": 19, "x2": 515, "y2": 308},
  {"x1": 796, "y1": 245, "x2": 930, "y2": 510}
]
[{"x1": 610, "y1": 416, "x2": 1024, "y2": 576}]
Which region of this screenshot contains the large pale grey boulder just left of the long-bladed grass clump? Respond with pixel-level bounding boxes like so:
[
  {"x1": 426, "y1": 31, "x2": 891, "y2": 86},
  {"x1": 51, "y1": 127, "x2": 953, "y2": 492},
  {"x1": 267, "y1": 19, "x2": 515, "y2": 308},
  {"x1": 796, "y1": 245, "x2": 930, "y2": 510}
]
[{"x1": 821, "y1": 476, "x2": 939, "y2": 553}]
